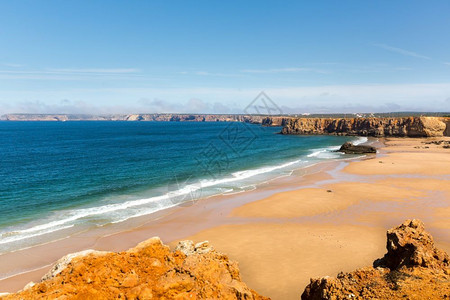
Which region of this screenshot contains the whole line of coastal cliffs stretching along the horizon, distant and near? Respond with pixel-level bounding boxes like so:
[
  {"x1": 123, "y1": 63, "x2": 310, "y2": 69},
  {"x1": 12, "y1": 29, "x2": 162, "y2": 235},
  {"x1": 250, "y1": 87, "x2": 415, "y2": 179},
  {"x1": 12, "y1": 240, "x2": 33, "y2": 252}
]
[{"x1": 1, "y1": 114, "x2": 450, "y2": 137}]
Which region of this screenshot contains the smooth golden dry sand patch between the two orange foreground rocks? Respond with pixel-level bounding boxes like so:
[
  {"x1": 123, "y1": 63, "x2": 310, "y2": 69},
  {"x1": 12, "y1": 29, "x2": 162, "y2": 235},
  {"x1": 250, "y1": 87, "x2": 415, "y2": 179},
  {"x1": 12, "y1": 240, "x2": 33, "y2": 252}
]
[{"x1": 183, "y1": 222, "x2": 385, "y2": 299}]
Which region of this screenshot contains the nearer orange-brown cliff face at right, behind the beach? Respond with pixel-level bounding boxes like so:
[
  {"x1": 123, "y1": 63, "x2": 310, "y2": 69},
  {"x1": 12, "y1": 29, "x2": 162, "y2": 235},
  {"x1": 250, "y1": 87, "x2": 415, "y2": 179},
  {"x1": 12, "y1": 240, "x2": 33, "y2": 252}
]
[{"x1": 281, "y1": 117, "x2": 450, "y2": 137}]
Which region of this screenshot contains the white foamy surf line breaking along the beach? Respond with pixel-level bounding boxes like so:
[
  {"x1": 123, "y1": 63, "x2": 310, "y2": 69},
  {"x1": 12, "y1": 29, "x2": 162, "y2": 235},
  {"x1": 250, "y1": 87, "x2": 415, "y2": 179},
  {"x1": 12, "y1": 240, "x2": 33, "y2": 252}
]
[{"x1": 0, "y1": 132, "x2": 362, "y2": 254}]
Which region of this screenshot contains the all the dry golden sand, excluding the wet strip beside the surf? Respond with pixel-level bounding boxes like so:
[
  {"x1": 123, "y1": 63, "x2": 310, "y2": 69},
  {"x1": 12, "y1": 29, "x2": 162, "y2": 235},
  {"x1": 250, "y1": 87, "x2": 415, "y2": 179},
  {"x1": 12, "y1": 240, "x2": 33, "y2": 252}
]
[{"x1": 174, "y1": 138, "x2": 450, "y2": 299}]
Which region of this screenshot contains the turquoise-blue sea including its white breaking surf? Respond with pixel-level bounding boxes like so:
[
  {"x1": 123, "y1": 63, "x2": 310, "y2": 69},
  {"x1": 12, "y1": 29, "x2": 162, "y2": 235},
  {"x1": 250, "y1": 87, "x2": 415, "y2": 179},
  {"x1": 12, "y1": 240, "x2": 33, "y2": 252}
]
[{"x1": 0, "y1": 122, "x2": 362, "y2": 253}]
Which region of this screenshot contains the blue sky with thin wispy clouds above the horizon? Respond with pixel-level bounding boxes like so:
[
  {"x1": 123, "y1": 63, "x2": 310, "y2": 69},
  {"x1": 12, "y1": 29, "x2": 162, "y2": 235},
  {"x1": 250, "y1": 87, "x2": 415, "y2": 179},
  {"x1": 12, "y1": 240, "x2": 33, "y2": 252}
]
[{"x1": 0, "y1": 0, "x2": 450, "y2": 115}]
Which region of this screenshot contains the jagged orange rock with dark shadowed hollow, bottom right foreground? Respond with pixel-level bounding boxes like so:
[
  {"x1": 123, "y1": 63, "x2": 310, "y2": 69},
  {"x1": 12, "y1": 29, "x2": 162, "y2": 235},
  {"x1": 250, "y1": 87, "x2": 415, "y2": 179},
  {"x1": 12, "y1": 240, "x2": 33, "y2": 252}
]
[{"x1": 302, "y1": 220, "x2": 450, "y2": 300}]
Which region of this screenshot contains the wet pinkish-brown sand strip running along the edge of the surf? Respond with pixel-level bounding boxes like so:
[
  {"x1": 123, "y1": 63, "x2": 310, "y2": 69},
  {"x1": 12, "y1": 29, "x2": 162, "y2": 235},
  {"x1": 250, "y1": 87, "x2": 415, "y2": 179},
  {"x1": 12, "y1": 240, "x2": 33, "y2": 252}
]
[{"x1": 0, "y1": 146, "x2": 362, "y2": 292}]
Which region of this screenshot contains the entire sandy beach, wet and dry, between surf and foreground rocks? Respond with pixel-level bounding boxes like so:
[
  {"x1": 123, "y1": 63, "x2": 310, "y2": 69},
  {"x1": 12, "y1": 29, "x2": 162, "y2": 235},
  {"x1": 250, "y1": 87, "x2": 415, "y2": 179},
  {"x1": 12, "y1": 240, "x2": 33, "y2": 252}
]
[{"x1": 0, "y1": 137, "x2": 450, "y2": 299}]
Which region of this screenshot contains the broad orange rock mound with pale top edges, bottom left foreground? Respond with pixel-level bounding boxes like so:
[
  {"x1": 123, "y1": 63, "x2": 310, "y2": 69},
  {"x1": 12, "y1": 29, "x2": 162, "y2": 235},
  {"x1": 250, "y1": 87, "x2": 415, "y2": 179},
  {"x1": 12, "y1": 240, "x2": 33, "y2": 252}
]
[{"x1": 0, "y1": 238, "x2": 269, "y2": 300}]
